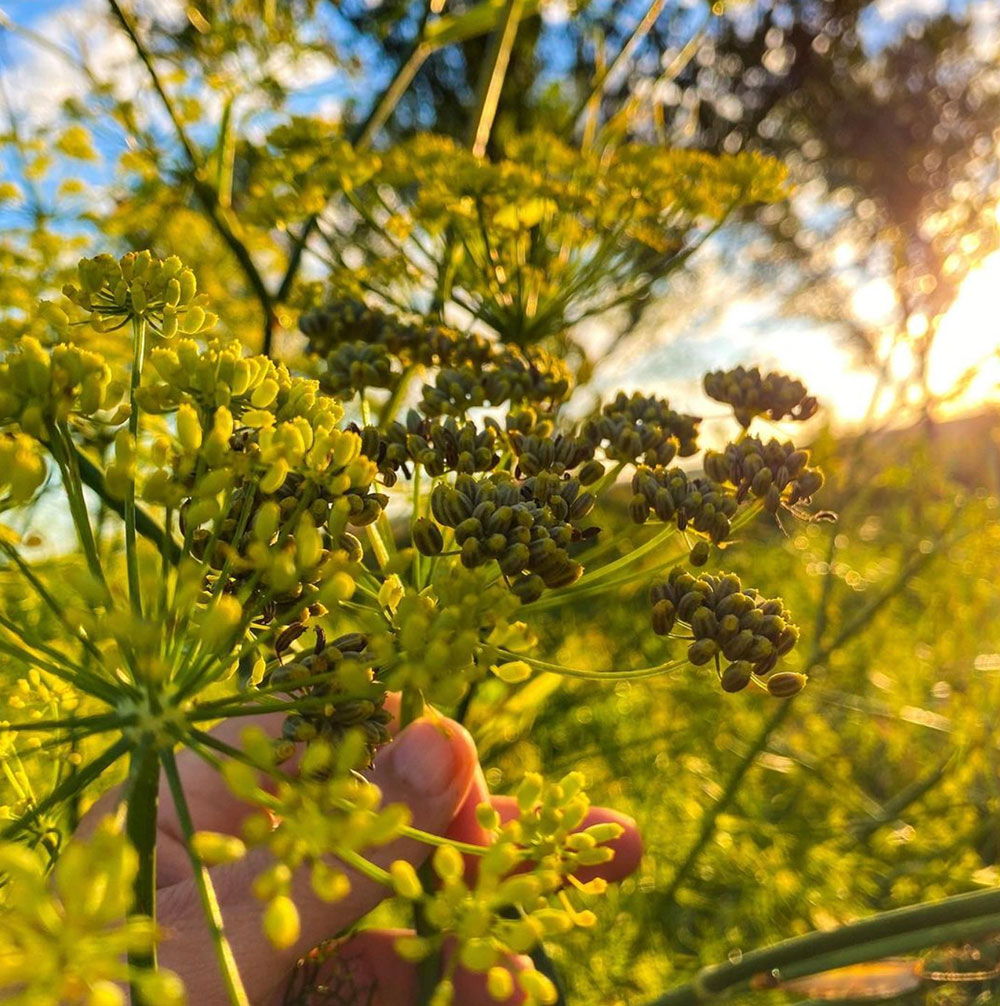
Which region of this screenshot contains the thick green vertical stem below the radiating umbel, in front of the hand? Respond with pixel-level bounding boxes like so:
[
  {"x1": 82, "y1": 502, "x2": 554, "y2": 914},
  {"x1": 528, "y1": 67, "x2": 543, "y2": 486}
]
[{"x1": 125, "y1": 742, "x2": 160, "y2": 993}]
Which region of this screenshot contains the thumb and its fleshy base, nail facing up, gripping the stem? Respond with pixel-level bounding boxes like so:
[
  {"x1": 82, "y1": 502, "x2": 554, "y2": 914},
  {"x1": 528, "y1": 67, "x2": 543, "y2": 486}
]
[{"x1": 160, "y1": 718, "x2": 478, "y2": 1002}]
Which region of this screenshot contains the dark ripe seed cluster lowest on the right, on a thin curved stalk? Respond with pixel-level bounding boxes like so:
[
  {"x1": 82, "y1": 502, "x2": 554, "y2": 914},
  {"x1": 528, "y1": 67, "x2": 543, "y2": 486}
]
[{"x1": 650, "y1": 566, "x2": 805, "y2": 696}]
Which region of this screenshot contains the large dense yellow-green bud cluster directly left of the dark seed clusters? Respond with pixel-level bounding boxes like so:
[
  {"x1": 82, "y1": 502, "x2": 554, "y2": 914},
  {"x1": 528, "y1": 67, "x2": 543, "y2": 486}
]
[{"x1": 138, "y1": 340, "x2": 386, "y2": 610}]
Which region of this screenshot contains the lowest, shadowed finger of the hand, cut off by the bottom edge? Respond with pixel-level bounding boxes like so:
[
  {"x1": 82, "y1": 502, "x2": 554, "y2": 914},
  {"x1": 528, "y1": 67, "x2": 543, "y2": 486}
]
[{"x1": 300, "y1": 930, "x2": 533, "y2": 1006}]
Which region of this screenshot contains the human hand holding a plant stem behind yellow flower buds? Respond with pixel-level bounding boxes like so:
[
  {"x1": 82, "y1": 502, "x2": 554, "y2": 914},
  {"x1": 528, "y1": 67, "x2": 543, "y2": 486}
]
[{"x1": 80, "y1": 713, "x2": 642, "y2": 1006}]
